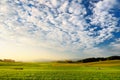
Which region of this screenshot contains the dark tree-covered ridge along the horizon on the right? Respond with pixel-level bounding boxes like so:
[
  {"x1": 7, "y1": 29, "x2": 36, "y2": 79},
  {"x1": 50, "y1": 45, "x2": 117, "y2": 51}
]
[{"x1": 57, "y1": 56, "x2": 120, "y2": 63}]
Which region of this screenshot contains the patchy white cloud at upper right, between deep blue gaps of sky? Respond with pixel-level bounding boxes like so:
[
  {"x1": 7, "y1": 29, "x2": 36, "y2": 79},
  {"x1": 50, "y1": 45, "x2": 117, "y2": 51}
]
[{"x1": 90, "y1": 0, "x2": 118, "y2": 43}]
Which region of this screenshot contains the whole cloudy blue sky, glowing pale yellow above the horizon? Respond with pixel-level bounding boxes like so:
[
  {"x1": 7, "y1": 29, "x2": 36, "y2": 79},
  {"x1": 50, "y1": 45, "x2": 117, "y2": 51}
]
[{"x1": 0, "y1": 0, "x2": 120, "y2": 61}]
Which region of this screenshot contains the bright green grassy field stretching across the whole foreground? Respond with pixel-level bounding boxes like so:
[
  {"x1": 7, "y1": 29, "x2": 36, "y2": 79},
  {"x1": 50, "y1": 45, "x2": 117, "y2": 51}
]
[{"x1": 0, "y1": 60, "x2": 120, "y2": 80}]
